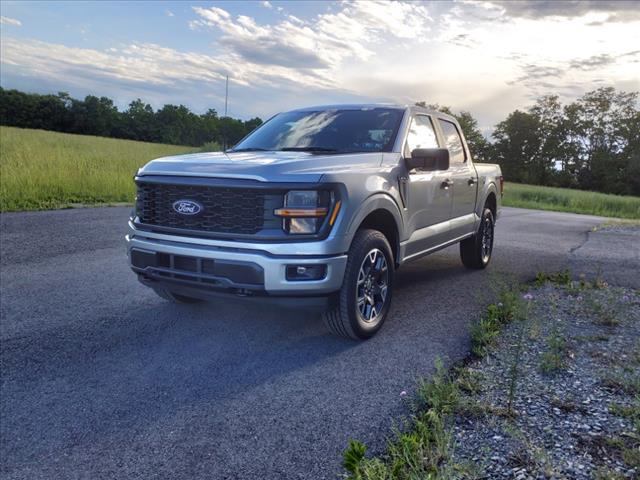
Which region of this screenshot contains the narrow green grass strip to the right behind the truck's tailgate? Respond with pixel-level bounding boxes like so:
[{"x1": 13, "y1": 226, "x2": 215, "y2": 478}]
[{"x1": 502, "y1": 182, "x2": 640, "y2": 219}]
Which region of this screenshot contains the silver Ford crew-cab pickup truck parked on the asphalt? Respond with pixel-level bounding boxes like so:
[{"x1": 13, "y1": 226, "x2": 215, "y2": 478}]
[{"x1": 126, "y1": 105, "x2": 503, "y2": 339}]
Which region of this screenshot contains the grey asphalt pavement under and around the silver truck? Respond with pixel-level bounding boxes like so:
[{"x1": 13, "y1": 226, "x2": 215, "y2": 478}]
[{"x1": 0, "y1": 208, "x2": 638, "y2": 480}]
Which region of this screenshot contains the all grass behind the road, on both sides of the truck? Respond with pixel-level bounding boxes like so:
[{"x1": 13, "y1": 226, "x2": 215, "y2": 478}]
[{"x1": 0, "y1": 127, "x2": 640, "y2": 219}]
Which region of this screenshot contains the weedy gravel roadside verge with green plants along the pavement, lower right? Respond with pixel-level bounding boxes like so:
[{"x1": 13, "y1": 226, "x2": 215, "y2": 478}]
[{"x1": 343, "y1": 271, "x2": 640, "y2": 480}]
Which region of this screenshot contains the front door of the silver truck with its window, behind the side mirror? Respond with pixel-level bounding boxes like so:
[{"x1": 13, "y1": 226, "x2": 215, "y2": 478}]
[{"x1": 404, "y1": 114, "x2": 453, "y2": 256}]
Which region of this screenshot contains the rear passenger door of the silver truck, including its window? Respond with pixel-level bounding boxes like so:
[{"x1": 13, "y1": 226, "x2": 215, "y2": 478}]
[{"x1": 438, "y1": 118, "x2": 478, "y2": 235}]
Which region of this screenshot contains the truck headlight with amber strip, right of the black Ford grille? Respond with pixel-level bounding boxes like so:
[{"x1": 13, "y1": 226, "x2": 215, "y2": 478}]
[{"x1": 274, "y1": 190, "x2": 331, "y2": 235}]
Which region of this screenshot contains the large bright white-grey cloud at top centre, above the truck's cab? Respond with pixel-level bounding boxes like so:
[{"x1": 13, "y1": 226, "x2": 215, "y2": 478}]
[{"x1": 189, "y1": 1, "x2": 431, "y2": 70}]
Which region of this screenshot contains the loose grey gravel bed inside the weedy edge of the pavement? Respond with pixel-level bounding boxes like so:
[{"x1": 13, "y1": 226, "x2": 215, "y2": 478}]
[{"x1": 454, "y1": 282, "x2": 640, "y2": 479}]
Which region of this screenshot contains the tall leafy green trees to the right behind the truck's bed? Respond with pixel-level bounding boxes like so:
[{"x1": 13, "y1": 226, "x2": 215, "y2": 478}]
[{"x1": 418, "y1": 87, "x2": 640, "y2": 195}]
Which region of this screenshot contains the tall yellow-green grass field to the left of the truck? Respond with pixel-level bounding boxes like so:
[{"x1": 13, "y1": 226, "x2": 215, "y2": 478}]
[{"x1": 0, "y1": 127, "x2": 196, "y2": 211}]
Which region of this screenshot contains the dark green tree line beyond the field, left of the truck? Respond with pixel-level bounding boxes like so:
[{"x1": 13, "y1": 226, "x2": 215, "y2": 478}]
[{"x1": 0, "y1": 87, "x2": 262, "y2": 148}]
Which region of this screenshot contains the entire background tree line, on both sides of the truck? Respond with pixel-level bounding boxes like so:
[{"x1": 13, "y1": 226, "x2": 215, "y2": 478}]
[{"x1": 0, "y1": 87, "x2": 640, "y2": 195}]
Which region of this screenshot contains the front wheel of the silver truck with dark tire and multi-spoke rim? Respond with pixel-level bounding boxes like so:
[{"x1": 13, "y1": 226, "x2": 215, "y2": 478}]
[{"x1": 323, "y1": 229, "x2": 394, "y2": 340}]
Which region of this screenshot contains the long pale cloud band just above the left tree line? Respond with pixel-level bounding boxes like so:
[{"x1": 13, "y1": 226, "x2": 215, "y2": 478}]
[{"x1": 1, "y1": 37, "x2": 331, "y2": 101}]
